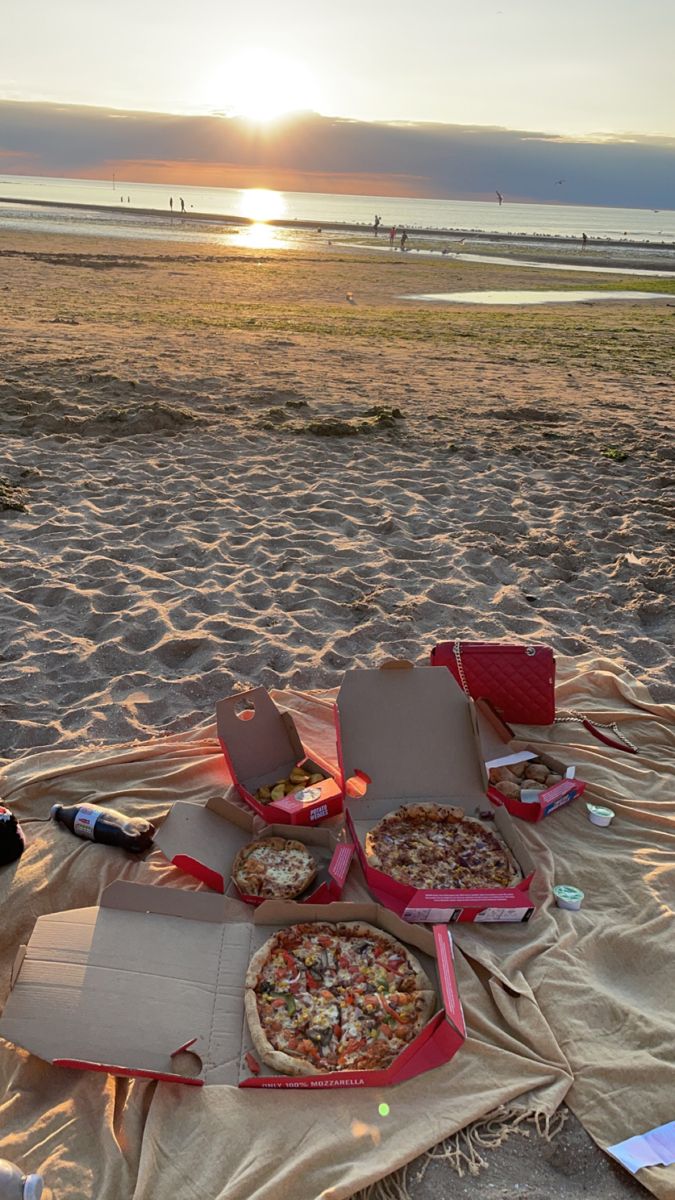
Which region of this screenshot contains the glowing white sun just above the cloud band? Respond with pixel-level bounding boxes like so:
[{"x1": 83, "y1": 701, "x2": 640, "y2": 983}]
[{"x1": 222, "y1": 48, "x2": 319, "y2": 121}]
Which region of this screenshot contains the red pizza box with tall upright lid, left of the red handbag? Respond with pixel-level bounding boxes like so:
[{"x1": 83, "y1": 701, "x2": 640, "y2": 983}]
[{"x1": 336, "y1": 660, "x2": 534, "y2": 922}]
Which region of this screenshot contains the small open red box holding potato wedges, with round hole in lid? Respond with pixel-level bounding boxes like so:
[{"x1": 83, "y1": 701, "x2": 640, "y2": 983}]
[{"x1": 216, "y1": 688, "x2": 342, "y2": 826}]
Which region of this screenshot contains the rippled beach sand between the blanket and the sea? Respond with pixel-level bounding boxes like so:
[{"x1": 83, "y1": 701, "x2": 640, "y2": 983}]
[{"x1": 0, "y1": 234, "x2": 675, "y2": 1200}]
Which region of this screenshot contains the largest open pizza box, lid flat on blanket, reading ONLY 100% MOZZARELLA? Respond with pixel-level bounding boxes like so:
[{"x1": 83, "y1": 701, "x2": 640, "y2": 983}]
[{"x1": 0, "y1": 880, "x2": 466, "y2": 1087}]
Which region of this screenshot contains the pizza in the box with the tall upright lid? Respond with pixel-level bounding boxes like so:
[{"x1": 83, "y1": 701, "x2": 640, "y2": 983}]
[{"x1": 365, "y1": 804, "x2": 522, "y2": 890}]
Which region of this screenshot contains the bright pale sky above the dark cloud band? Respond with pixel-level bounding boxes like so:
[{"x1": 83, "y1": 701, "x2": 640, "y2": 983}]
[{"x1": 0, "y1": 0, "x2": 675, "y2": 136}]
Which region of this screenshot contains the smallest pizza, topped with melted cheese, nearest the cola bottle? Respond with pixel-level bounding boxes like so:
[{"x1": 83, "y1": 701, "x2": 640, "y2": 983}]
[{"x1": 232, "y1": 838, "x2": 317, "y2": 900}]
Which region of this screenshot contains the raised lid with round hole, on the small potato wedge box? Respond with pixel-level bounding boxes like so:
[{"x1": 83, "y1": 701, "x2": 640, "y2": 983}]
[{"x1": 216, "y1": 688, "x2": 305, "y2": 786}]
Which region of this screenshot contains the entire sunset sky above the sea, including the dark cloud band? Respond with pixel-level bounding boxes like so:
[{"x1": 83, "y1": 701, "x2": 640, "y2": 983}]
[{"x1": 0, "y1": 0, "x2": 675, "y2": 201}]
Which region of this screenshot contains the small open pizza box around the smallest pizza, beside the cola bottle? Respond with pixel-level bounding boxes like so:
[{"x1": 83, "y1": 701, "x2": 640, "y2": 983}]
[{"x1": 155, "y1": 796, "x2": 354, "y2": 905}]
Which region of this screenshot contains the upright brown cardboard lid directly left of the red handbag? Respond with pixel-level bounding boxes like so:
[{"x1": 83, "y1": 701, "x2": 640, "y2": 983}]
[{"x1": 336, "y1": 661, "x2": 486, "y2": 817}]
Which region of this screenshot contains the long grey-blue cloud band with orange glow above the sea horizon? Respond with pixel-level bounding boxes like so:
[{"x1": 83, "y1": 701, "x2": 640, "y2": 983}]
[{"x1": 0, "y1": 101, "x2": 675, "y2": 208}]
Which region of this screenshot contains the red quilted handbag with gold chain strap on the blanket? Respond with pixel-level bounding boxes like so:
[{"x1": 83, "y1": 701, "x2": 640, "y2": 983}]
[{"x1": 431, "y1": 637, "x2": 555, "y2": 725}]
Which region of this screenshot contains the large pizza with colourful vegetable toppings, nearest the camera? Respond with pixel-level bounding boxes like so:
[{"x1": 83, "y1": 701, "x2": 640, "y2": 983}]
[{"x1": 245, "y1": 922, "x2": 436, "y2": 1075}]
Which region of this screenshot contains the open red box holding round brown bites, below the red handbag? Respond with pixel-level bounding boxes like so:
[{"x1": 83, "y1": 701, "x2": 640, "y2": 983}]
[{"x1": 476, "y1": 700, "x2": 586, "y2": 822}]
